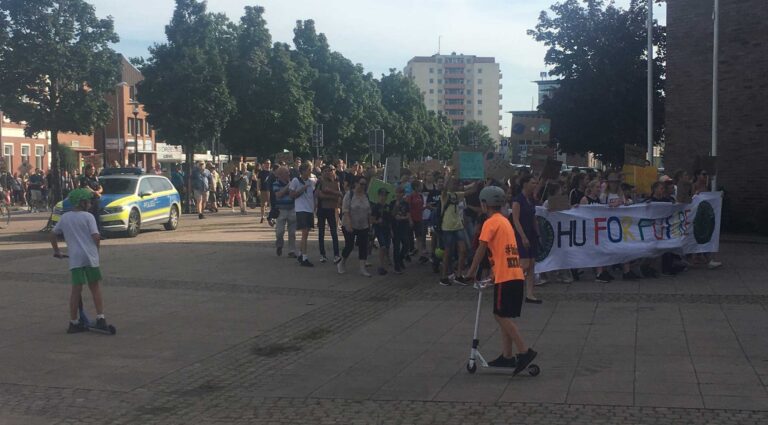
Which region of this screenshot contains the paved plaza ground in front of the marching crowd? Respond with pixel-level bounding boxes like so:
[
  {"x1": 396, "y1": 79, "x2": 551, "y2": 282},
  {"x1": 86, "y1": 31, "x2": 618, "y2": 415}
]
[{"x1": 0, "y1": 211, "x2": 768, "y2": 424}]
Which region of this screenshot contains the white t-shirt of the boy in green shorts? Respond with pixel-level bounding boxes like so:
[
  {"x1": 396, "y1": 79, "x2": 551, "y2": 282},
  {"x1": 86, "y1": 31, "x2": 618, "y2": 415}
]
[{"x1": 53, "y1": 211, "x2": 99, "y2": 270}]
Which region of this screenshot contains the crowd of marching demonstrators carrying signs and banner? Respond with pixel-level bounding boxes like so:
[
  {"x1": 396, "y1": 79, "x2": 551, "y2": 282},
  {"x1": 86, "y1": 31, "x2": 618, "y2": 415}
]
[{"x1": 195, "y1": 158, "x2": 721, "y2": 303}]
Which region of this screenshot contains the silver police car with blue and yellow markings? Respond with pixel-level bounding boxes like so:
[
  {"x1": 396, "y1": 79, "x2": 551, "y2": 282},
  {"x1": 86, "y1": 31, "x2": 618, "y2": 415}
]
[{"x1": 51, "y1": 168, "x2": 181, "y2": 237}]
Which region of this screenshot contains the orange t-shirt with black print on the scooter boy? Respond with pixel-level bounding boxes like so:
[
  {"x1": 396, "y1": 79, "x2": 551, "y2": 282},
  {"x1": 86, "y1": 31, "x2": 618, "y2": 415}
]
[{"x1": 480, "y1": 213, "x2": 525, "y2": 283}]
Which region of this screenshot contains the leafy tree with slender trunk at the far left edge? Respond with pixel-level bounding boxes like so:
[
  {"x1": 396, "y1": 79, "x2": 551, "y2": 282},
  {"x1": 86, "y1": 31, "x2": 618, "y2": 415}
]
[{"x1": 0, "y1": 0, "x2": 119, "y2": 201}]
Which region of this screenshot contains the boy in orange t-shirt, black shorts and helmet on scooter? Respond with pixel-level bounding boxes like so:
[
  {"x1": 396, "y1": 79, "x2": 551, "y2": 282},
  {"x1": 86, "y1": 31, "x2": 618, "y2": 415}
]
[{"x1": 467, "y1": 186, "x2": 537, "y2": 375}]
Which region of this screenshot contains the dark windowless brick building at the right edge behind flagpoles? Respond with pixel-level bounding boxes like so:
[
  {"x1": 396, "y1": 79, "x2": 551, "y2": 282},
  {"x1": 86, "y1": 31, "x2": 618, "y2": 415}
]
[{"x1": 664, "y1": 0, "x2": 768, "y2": 233}]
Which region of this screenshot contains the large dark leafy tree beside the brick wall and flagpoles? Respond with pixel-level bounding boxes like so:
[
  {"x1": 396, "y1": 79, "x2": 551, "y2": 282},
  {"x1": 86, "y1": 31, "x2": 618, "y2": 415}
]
[{"x1": 528, "y1": 0, "x2": 666, "y2": 164}]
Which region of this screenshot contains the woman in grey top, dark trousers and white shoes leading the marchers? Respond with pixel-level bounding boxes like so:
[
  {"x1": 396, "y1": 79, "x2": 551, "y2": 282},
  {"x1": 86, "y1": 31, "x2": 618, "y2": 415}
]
[{"x1": 336, "y1": 177, "x2": 371, "y2": 277}]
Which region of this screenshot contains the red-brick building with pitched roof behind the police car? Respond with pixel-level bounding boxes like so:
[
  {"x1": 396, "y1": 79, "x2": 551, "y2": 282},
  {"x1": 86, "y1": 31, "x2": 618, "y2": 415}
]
[{"x1": 95, "y1": 55, "x2": 157, "y2": 169}]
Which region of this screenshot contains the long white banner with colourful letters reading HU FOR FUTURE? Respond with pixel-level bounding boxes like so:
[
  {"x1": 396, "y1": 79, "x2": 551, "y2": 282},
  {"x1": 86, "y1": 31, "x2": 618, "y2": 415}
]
[{"x1": 536, "y1": 192, "x2": 722, "y2": 273}]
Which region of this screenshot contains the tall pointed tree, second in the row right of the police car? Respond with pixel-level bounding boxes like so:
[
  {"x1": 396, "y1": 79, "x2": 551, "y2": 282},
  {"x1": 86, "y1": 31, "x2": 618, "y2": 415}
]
[{"x1": 224, "y1": 6, "x2": 313, "y2": 156}]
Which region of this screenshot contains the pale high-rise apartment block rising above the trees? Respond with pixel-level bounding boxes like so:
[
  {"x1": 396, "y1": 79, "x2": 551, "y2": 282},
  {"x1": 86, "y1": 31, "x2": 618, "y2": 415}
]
[{"x1": 403, "y1": 53, "x2": 502, "y2": 142}]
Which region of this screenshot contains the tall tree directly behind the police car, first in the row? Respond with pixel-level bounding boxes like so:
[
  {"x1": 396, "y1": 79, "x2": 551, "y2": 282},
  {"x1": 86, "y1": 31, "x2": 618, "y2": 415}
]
[{"x1": 137, "y1": 0, "x2": 235, "y2": 200}]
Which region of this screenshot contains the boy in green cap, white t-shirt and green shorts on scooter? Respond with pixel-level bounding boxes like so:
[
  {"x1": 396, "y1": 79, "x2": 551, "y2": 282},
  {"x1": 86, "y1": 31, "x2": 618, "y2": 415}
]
[{"x1": 51, "y1": 188, "x2": 108, "y2": 333}]
